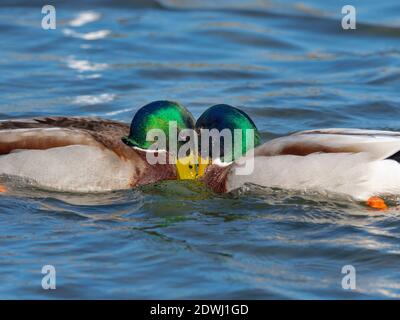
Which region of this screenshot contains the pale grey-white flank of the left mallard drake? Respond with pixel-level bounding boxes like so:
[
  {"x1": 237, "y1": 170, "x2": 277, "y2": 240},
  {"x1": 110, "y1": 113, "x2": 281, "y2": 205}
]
[{"x1": 0, "y1": 145, "x2": 132, "y2": 192}]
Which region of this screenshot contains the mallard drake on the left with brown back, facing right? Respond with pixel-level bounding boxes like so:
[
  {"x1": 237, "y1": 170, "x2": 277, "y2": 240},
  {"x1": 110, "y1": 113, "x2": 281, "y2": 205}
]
[{"x1": 0, "y1": 101, "x2": 194, "y2": 192}]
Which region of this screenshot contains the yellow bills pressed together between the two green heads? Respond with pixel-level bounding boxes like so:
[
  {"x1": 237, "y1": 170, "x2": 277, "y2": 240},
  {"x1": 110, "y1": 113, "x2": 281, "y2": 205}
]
[{"x1": 176, "y1": 153, "x2": 210, "y2": 180}]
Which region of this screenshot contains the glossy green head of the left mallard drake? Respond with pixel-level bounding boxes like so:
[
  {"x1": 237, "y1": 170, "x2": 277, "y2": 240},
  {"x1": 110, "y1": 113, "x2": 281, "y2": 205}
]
[{"x1": 122, "y1": 100, "x2": 194, "y2": 149}]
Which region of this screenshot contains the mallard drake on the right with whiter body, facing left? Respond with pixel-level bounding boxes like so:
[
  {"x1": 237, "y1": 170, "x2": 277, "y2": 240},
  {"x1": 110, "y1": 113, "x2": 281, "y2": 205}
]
[{"x1": 196, "y1": 105, "x2": 400, "y2": 205}]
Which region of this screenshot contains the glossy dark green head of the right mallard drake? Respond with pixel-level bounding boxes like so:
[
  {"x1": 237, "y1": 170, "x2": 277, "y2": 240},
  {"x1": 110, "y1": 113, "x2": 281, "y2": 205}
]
[{"x1": 196, "y1": 104, "x2": 261, "y2": 161}]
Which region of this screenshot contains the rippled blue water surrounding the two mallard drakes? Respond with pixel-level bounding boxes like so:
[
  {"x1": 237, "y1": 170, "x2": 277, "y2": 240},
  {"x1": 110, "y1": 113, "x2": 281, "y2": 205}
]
[{"x1": 0, "y1": 0, "x2": 400, "y2": 299}]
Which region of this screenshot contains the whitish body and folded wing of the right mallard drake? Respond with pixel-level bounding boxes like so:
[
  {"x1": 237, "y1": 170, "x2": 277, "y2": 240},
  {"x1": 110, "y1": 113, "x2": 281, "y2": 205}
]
[{"x1": 226, "y1": 129, "x2": 400, "y2": 200}]
